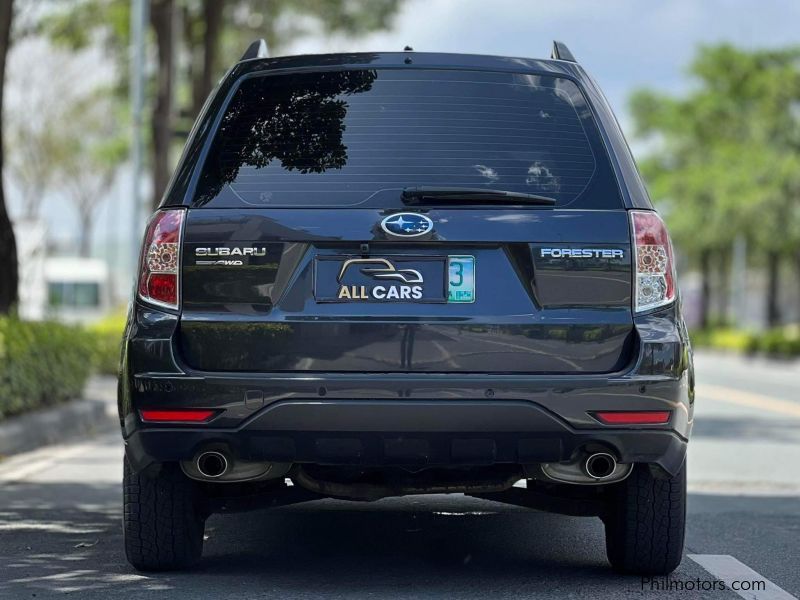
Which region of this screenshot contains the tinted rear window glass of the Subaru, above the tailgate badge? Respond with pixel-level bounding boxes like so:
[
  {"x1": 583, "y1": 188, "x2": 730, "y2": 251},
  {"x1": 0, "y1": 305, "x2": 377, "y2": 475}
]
[{"x1": 194, "y1": 69, "x2": 622, "y2": 208}]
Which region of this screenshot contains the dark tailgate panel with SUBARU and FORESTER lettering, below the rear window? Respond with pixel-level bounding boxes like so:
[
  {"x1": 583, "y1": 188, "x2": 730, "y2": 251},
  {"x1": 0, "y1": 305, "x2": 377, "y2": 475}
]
[{"x1": 177, "y1": 208, "x2": 634, "y2": 374}]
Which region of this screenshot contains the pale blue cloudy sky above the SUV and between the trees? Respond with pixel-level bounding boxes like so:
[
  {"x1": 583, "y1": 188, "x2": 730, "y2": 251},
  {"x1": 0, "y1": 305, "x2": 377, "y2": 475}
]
[{"x1": 7, "y1": 0, "x2": 800, "y2": 282}]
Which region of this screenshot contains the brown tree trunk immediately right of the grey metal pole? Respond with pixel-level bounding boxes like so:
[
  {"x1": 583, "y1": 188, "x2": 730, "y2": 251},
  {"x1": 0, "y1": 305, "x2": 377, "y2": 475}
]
[{"x1": 150, "y1": 0, "x2": 175, "y2": 208}]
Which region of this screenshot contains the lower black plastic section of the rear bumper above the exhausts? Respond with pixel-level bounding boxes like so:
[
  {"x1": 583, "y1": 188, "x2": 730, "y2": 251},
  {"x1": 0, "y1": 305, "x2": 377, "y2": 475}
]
[{"x1": 126, "y1": 400, "x2": 687, "y2": 473}]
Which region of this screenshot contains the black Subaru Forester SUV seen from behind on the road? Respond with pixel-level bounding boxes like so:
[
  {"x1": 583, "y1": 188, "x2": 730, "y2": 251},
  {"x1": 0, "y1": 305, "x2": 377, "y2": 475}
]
[{"x1": 119, "y1": 42, "x2": 694, "y2": 574}]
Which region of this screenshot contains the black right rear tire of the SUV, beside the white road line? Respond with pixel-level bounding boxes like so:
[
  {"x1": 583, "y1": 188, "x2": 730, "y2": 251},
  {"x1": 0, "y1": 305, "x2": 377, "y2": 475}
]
[{"x1": 603, "y1": 462, "x2": 686, "y2": 575}]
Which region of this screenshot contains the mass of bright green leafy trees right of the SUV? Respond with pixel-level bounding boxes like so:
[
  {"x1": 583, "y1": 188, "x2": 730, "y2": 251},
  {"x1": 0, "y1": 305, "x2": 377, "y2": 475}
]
[{"x1": 631, "y1": 44, "x2": 800, "y2": 325}]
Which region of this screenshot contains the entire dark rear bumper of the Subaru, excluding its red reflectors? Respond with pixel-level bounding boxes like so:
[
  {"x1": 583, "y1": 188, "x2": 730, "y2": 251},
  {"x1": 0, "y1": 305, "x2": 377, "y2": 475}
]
[{"x1": 119, "y1": 307, "x2": 694, "y2": 473}]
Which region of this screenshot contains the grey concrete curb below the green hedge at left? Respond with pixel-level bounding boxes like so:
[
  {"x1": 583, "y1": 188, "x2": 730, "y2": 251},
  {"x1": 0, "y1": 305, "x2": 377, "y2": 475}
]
[{"x1": 0, "y1": 400, "x2": 111, "y2": 456}]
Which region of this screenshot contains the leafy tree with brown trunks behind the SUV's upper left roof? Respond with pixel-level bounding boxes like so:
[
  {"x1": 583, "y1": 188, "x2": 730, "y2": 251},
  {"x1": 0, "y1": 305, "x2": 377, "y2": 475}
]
[{"x1": 44, "y1": 0, "x2": 401, "y2": 216}]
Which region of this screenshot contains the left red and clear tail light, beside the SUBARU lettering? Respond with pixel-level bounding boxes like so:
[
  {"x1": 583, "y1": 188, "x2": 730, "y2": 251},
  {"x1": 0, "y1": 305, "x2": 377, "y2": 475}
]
[{"x1": 138, "y1": 210, "x2": 184, "y2": 309}]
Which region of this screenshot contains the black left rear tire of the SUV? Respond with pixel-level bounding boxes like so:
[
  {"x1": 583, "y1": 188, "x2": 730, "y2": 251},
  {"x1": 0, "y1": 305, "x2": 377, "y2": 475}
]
[{"x1": 123, "y1": 457, "x2": 205, "y2": 571}]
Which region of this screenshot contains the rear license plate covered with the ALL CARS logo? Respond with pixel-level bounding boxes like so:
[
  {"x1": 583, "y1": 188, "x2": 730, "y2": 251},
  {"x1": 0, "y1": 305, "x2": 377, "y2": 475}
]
[{"x1": 314, "y1": 255, "x2": 475, "y2": 304}]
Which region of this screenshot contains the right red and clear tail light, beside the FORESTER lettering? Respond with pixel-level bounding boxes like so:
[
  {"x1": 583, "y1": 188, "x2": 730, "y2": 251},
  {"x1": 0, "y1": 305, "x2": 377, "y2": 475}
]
[{"x1": 630, "y1": 210, "x2": 676, "y2": 312}]
